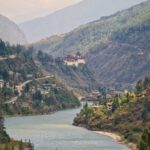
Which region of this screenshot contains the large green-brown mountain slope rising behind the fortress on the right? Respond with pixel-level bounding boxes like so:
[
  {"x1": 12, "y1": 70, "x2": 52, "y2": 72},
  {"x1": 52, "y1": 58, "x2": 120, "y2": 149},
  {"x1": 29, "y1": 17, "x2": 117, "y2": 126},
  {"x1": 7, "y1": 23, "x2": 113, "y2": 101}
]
[{"x1": 34, "y1": 1, "x2": 150, "y2": 86}]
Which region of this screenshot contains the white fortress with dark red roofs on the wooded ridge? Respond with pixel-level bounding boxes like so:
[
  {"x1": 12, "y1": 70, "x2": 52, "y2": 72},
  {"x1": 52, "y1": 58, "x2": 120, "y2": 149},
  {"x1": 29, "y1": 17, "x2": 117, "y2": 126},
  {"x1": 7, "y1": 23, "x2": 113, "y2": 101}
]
[{"x1": 57, "y1": 55, "x2": 86, "y2": 67}]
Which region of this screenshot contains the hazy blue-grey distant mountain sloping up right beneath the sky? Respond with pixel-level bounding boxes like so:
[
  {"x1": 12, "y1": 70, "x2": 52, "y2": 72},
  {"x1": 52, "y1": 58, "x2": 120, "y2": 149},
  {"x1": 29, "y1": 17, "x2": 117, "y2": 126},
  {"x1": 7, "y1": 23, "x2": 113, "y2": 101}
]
[{"x1": 20, "y1": 0, "x2": 144, "y2": 42}]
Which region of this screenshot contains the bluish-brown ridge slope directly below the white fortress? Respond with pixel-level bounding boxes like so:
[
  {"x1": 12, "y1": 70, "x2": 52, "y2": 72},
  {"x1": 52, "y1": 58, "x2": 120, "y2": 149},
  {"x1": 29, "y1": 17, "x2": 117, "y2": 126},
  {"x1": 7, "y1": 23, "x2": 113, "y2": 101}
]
[{"x1": 36, "y1": 51, "x2": 100, "y2": 89}]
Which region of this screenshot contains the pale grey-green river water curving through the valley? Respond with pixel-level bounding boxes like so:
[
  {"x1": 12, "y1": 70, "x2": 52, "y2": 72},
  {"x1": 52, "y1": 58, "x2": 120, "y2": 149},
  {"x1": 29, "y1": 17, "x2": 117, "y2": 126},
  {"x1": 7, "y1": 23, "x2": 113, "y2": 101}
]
[{"x1": 5, "y1": 109, "x2": 129, "y2": 150}]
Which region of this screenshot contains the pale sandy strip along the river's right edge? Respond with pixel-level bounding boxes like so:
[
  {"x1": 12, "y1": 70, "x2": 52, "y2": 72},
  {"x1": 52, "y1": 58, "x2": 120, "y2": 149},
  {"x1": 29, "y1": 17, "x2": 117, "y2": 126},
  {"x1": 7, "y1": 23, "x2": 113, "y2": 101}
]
[{"x1": 93, "y1": 131, "x2": 137, "y2": 150}]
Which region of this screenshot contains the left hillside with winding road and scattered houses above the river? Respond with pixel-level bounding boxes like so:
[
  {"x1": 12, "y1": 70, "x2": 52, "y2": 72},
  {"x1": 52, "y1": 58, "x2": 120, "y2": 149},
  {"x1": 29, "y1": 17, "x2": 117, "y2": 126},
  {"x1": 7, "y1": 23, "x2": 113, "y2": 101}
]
[{"x1": 0, "y1": 40, "x2": 80, "y2": 115}]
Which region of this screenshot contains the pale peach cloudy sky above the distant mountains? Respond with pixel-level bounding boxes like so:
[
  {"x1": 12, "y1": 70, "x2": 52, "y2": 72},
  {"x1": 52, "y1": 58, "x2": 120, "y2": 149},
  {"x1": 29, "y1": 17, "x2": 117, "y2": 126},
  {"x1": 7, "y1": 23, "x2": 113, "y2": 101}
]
[{"x1": 0, "y1": 0, "x2": 81, "y2": 23}]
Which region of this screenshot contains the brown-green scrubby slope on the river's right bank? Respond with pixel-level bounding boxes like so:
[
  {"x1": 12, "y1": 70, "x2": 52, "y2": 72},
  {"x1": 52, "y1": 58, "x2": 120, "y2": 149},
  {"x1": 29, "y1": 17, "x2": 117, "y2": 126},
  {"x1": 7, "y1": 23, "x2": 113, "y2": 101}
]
[{"x1": 74, "y1": 77, "x2": 150, "y2": 150}]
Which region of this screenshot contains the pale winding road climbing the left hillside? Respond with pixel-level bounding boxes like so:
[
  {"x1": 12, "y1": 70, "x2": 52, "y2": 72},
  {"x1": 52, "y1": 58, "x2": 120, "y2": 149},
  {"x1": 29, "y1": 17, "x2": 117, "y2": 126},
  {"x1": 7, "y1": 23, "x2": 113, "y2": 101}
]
[{"x1": 4, "y1": 75, "x2": 54, "y2": 104}]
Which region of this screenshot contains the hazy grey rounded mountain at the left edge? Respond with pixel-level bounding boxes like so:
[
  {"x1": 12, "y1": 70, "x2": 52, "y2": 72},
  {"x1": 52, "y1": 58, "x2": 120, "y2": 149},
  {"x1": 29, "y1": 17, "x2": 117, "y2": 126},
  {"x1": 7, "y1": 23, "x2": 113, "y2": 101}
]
[{"x1": 0, "y1": 15, "x2": 27, "y2": 44}]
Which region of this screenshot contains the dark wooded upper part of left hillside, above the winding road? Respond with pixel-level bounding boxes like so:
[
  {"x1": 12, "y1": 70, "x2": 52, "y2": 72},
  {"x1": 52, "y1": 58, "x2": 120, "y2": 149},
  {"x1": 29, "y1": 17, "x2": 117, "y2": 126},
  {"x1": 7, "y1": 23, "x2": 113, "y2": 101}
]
[{"x1": 0, "y1": 40, "x2": 40, "y2": 83}]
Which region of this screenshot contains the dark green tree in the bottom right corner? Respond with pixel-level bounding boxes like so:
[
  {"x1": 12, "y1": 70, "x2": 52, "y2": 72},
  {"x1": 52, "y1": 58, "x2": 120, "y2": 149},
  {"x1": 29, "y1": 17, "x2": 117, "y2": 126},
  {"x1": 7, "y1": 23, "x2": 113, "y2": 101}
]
[{"x1": 138, "y1": 126, "x2": 150, "y2": 150}]
